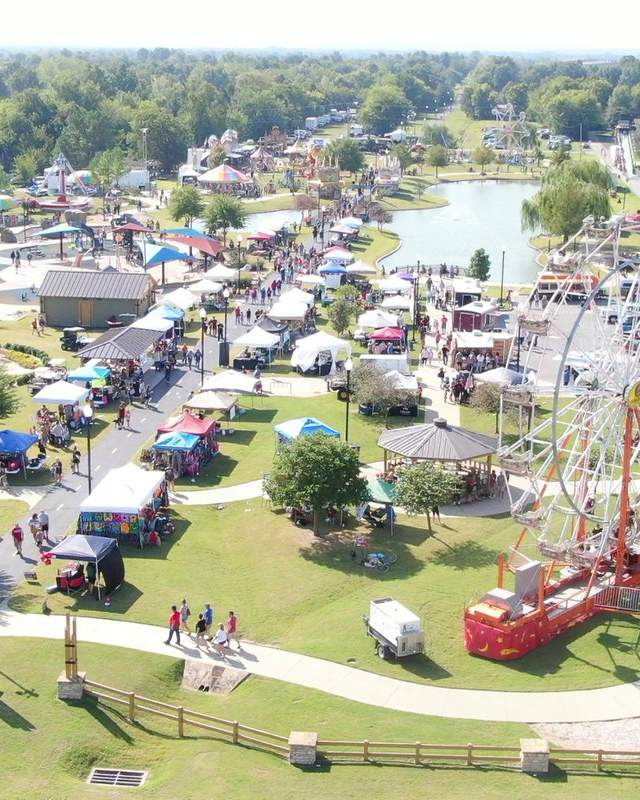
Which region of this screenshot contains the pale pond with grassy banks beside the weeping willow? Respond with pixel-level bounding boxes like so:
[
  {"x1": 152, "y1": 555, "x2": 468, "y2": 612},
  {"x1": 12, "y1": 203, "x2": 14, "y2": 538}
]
[{"x1": 383, "y1": 181, "x2": 538, "y2": 283}]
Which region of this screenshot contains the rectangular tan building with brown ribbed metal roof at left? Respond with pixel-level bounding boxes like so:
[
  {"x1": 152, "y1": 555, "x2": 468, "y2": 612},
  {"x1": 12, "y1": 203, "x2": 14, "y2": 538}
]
[{"x1": 38, "y1": 269, "x2": 155, "y2": 328}]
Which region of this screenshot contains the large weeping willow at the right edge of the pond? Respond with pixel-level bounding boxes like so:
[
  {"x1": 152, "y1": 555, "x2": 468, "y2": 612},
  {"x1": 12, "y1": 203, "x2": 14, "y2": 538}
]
[{"x1": 520, "y1": 159, "x2": 612, "y2": 241}]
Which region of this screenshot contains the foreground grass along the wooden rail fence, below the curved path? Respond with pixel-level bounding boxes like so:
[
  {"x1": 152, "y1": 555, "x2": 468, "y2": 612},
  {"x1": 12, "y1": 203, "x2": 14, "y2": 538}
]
[{"x1": 11, "y1": 639, "x2": 620, "y2": 800}]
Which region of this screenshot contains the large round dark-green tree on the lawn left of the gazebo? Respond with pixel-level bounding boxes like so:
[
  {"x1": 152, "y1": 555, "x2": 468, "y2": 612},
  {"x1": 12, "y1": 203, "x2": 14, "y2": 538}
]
[{"x1": 263, "y1": 433, "x2": 369, "y2": 534}]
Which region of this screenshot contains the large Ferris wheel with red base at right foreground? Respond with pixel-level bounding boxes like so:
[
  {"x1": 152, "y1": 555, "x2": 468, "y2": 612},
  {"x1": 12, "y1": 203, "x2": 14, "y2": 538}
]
[{"x1": 465, "y1": 211, "x2": 640, "y2": 661}]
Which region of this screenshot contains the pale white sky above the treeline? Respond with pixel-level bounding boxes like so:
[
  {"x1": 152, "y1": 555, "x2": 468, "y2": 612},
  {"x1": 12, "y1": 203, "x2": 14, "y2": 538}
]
[{"x1": 0, "y1": 0, "x2": 640, "y2": 53}]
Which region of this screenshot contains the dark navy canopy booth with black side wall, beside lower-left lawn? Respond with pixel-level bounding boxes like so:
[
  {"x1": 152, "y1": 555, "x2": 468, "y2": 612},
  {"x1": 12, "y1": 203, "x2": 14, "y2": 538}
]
[{"x1": 42, "y1": 535, "x2": 124, "y2": 598}]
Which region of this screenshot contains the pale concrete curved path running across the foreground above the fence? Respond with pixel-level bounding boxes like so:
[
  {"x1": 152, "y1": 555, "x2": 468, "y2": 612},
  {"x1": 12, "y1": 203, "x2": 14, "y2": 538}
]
[{"x1": 0, "y1": 610, "x2": 640, "y2": 723}]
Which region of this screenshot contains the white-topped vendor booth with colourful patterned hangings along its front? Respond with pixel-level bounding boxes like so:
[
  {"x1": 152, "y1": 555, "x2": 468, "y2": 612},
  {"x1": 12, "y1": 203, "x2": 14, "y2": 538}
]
[{"x1": 78, "y1": 464, "x2": 169, "y2": 547}]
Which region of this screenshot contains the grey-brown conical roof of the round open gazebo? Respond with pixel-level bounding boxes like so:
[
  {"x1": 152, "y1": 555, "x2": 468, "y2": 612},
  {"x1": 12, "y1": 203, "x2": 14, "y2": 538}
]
[{"x1": 378, "y1": 418, "x2": 498, "y2": 461}]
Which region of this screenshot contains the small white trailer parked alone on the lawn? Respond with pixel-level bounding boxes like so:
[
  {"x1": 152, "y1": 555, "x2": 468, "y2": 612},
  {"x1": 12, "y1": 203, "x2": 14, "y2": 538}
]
[{"x1": 364, "y1": 597, "x2": 424, "y2": 658}]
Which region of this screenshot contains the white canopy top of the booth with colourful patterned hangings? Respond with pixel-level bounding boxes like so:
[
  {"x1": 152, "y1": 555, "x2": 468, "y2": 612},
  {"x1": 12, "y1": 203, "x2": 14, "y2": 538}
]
[{"x1": 80, "y1": 464, "x2": 164, "y2": 514}]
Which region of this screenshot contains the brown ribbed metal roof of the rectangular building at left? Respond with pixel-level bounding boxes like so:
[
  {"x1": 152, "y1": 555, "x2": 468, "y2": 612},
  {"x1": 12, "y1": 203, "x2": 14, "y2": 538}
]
[{"x1": 38, "y1": 269, "x2": 153, "y2": 300}]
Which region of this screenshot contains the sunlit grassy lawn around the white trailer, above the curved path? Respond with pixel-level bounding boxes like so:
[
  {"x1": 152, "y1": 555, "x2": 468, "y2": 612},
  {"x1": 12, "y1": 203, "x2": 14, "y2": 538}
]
[{"x1": 11, "y1": 499, "x2": 640, "y2": 691}]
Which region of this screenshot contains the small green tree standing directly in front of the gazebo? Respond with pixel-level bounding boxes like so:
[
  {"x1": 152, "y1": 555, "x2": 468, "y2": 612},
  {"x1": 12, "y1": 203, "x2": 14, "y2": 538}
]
[{"x1": 396, "y1": 461, "x2": 460, "y2": 531}]
